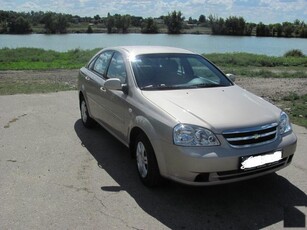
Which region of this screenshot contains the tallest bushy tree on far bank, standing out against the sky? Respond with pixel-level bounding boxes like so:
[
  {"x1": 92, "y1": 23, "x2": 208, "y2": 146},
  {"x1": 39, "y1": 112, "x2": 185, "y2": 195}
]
[{"x1": 164, "y1": 11, "x2": 184, "y2": 34}]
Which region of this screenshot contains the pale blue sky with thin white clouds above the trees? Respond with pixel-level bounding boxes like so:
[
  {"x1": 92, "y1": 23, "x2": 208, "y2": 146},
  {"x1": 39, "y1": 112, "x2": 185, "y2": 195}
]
[{"x1": 0, "y1": 0, "x2": 307, "y2": 24}]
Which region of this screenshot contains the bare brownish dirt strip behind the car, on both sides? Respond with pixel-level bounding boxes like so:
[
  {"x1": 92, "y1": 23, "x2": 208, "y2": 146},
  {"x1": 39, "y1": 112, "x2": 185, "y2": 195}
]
[{"x1": 0, "y1": 69, "x2": 307, "y2": 101}]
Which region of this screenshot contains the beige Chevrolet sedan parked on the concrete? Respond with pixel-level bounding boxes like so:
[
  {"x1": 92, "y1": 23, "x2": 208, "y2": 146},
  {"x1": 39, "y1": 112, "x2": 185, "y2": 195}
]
[{"x1": 78, "y1": 46, "x2": 297, "y2": 186}]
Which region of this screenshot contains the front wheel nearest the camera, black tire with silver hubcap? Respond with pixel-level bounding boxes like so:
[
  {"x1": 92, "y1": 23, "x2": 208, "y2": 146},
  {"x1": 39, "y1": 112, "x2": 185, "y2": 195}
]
[{"x1": 134, "y1": 133, "x2": 161, "y2": 187}]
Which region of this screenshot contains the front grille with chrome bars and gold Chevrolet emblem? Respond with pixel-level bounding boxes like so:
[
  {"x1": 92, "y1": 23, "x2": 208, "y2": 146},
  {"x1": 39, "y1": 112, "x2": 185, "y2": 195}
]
[{"x1": 223, "y1": 123, "x2": 278, "y2": 148}]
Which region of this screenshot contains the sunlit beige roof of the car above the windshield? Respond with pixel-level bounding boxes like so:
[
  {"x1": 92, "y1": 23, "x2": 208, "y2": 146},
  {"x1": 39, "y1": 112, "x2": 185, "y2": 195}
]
[{"x1": 109, "y1": 46, "x2": 193, "y2": 55}]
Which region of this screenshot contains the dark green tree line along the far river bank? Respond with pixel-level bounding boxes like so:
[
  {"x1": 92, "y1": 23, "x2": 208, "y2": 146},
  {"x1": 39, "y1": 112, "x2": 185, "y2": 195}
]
[{"x1": 0, "y1": 10, "x2": 307, "y2": 38}]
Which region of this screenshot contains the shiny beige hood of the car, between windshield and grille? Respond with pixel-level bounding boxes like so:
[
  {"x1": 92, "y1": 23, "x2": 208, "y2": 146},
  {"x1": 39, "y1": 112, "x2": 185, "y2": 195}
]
[{"x1": 142, "y1": 85, "x2": 281, "y2": 133}]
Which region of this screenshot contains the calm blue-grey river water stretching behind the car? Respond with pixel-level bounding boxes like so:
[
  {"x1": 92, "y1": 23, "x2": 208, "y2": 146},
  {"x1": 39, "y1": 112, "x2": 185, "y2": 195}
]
[{"x1": 0, "y1": 34, "x2": 307, "y2": 56}]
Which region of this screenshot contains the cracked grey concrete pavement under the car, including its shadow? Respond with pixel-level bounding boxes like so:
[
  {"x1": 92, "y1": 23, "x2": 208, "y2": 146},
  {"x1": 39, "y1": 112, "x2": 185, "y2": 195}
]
[{"x1": 0, "y1": 91, "x2": 307, "y2": 229}]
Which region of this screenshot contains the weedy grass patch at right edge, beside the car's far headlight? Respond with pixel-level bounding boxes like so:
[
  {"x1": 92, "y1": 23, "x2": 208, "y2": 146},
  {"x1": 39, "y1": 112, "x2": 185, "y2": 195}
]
[{"x1": 279, "y1": 93, "x2": 307, "y2": 128}]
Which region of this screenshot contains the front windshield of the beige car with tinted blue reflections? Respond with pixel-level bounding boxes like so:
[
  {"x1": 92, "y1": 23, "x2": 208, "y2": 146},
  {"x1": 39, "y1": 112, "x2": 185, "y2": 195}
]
[{"x1": 132, "y1": 54, "x2": 232, "y2": 90}]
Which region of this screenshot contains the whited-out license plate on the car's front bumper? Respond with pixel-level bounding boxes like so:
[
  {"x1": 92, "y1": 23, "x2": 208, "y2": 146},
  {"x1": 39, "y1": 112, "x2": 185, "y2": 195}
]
[{"x1": 240, "y1": 151, "x2": 282, "y2": 170}]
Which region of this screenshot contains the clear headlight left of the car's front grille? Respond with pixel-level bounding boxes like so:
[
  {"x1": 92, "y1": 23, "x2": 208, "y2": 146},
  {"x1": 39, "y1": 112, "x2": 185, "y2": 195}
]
[{"x1": 173, "y1": 124, "x2": 220, "y2": 146}]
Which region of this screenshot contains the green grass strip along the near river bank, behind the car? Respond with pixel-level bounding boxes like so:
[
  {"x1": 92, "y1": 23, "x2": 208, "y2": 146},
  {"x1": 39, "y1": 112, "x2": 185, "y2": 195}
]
[{"x1": 0, "y1": 48, "x2": 307, "y2": 71}]
